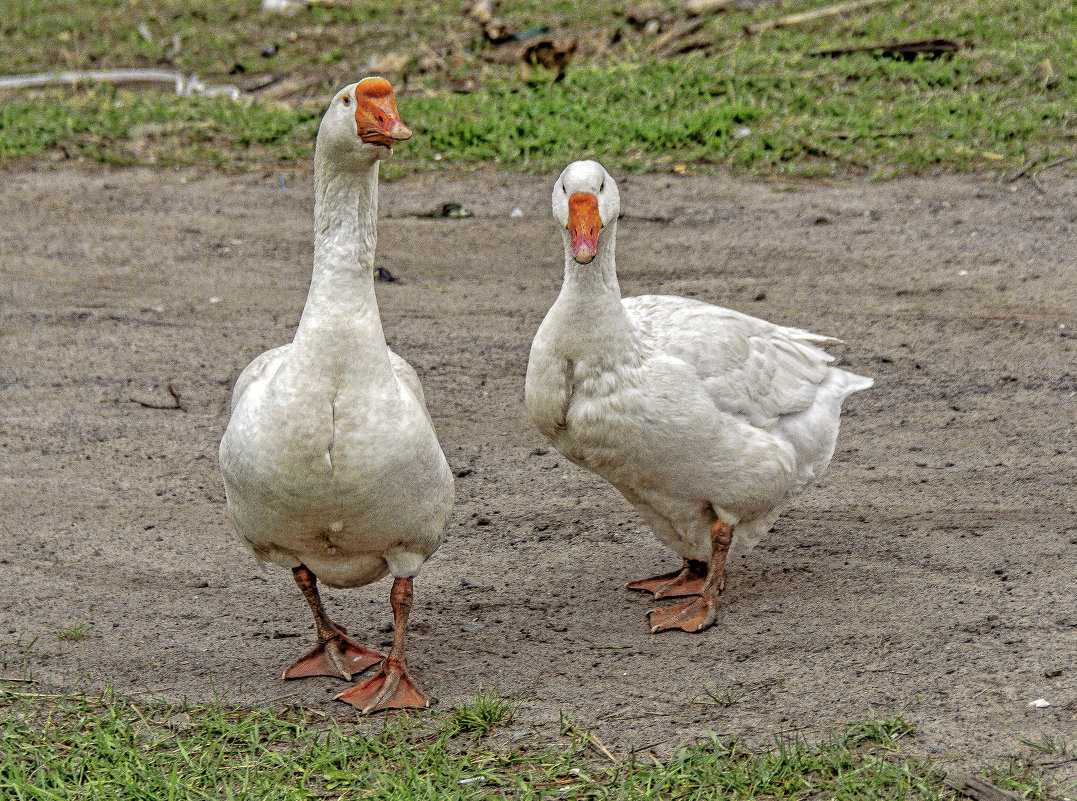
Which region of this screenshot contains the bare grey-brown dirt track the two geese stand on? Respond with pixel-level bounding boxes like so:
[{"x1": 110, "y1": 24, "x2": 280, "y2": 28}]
[{"x1": 0, "y1": 164, "x2": 1077, "y2": 771}]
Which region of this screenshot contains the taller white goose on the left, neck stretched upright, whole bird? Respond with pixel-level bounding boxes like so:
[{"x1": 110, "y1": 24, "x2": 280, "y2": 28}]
[{"x1": 221, "y1": 78, "x2": 452, "y2": 713}]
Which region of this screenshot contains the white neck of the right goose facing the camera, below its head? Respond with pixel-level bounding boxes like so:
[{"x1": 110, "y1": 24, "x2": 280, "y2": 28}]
[{"x1": 551, "y1": 223, "x2": 640, "y2": 363}]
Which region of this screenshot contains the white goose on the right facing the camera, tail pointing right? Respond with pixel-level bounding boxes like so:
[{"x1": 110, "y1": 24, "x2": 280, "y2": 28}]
[{"x1": 526, "y1": 161, "x2": 872, "y2": 632}]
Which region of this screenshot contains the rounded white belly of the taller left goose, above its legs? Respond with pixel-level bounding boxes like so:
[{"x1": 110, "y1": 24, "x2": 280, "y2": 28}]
[{"x1": 221, "y1": 385, "x2": 452, "y2": 587}]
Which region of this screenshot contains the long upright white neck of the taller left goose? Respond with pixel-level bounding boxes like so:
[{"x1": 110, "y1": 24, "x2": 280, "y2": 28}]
[{"x1": 292, "y1": 152, "x2": 391, "y2": 375}]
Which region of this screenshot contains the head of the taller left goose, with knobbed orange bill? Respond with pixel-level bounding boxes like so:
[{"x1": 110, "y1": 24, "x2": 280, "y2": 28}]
[{"x1": 318, "y1": 78, "x2": 411, "y2": 163}]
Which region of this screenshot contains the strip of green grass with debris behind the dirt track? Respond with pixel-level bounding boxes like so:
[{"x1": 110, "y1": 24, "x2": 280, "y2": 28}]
[{"x1": 0, "y1": 0, "x2": 1077, "y2": 178}]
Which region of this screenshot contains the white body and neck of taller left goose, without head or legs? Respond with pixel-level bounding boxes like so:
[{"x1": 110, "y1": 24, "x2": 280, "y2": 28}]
[{"x1": 220, "y1": 151, "x2": 453, "y2": 587}]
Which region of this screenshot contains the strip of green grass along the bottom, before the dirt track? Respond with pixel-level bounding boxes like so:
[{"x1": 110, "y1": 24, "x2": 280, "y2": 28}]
[{"x1": 0, "y1": 689, "x2": 1059, "y2": 801}]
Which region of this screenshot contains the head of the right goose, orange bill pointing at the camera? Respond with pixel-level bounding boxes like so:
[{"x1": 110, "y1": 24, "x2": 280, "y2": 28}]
[{"x1": 553, "y1": 161, "x2": 620, "y2": 264}]
